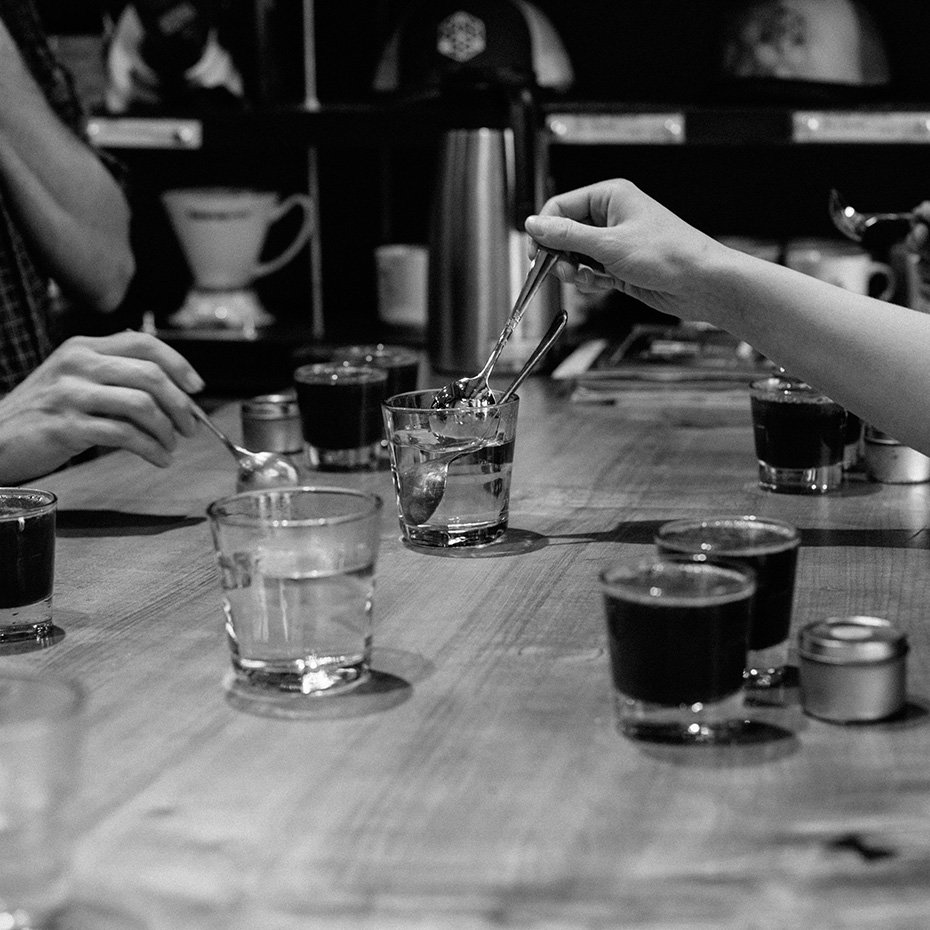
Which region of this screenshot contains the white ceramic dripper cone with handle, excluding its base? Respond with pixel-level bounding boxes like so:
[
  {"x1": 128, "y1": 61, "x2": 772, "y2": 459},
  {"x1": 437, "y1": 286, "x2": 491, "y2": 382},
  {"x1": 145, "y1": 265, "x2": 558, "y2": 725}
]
[{"x1": 162, "y1": 187, "x2": 313, "y2": 291}]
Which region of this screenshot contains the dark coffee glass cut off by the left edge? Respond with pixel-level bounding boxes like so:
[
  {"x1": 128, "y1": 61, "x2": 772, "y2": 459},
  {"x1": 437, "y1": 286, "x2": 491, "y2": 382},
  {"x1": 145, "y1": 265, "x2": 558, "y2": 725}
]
[{"x1": 0, "y1": 488, "x2": 58, "y2": 643}]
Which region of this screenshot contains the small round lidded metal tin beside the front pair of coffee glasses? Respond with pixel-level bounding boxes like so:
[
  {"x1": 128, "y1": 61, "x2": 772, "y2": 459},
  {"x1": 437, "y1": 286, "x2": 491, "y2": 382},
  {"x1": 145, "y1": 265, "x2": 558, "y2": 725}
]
[{"x1": 798, "y1": 616, "x2": 908, "y2": 723}]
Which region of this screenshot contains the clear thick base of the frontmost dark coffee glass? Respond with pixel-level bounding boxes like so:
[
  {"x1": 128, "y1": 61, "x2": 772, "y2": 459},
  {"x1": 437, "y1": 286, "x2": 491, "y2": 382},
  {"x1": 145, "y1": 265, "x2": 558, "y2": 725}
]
[{"x1": 614, "y1": 691, "x2": 747, "y2": 746}]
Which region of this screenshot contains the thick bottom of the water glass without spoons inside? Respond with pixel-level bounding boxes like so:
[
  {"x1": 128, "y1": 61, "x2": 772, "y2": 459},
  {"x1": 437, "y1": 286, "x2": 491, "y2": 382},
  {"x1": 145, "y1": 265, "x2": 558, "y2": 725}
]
[{"x1": 233, "y1": 656, "x2": 370, "y2": 699}]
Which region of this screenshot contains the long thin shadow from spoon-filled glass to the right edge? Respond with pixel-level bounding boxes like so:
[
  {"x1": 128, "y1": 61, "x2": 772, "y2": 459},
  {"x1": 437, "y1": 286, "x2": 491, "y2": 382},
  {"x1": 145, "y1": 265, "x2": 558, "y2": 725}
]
[{"x1": 496, "y1": 520, "x2": 930, "y2": 558}]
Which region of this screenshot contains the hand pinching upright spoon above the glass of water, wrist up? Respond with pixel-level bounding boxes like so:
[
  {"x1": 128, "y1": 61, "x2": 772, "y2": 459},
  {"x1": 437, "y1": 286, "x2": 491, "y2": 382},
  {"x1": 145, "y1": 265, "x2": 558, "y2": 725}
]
[{"x1": 526, "y1": 179, "x2": 724, "y2": 317}]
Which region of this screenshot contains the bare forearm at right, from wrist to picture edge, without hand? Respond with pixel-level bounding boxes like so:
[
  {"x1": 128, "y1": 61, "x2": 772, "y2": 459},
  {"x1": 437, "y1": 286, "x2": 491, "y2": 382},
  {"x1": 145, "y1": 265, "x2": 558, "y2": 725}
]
[{"x1": 695, "y1": 250, "x2": 930, "y2": 454}]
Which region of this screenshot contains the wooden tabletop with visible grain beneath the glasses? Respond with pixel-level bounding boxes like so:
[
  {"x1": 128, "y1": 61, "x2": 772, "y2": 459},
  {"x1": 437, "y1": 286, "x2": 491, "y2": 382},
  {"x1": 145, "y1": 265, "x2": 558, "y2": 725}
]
[{"x1": 10, "y1": 382, "x2": 930, "y2": 930}]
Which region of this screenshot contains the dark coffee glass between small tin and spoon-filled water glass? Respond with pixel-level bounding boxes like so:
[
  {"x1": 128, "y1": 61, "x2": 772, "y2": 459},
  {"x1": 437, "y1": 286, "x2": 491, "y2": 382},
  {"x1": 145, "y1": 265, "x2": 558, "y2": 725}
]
[{"x1": 294, "y1": 362, "x2": 388, "y2": 471}]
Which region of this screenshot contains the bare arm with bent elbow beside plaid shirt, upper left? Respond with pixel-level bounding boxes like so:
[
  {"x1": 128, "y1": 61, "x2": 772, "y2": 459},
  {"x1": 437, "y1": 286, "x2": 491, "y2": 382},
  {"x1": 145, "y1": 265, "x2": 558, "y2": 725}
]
[{"x1": 0, "y1": 21, "x2": 135, "y2": 311}]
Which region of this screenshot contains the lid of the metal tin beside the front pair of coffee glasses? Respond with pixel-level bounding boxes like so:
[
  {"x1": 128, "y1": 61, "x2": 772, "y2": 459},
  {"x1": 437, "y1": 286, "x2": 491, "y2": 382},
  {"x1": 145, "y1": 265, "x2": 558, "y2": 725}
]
[{"x1": 798, "y1": 617, "x2": 908, "y2": 665}]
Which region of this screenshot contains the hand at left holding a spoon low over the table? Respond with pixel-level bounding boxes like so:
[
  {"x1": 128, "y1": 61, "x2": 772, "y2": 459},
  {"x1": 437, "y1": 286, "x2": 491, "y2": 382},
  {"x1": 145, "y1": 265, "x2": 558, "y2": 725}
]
[{"x1": 0, "y1": 332, "x2": 204, "y2": 484}]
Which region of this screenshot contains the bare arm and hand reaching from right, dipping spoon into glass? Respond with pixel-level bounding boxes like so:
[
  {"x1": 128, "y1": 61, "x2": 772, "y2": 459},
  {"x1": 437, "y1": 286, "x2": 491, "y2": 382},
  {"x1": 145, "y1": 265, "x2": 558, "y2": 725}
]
[{"x1": 526, "y1": 180, "x2": 930, "y2": 454}]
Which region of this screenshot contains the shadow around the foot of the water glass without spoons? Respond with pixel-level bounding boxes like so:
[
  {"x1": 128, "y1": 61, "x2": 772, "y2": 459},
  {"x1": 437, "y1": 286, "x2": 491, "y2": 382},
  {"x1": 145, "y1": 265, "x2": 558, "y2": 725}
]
[{"x1": 225, "y1": 649, "x2": 435, "y2": 720}]
